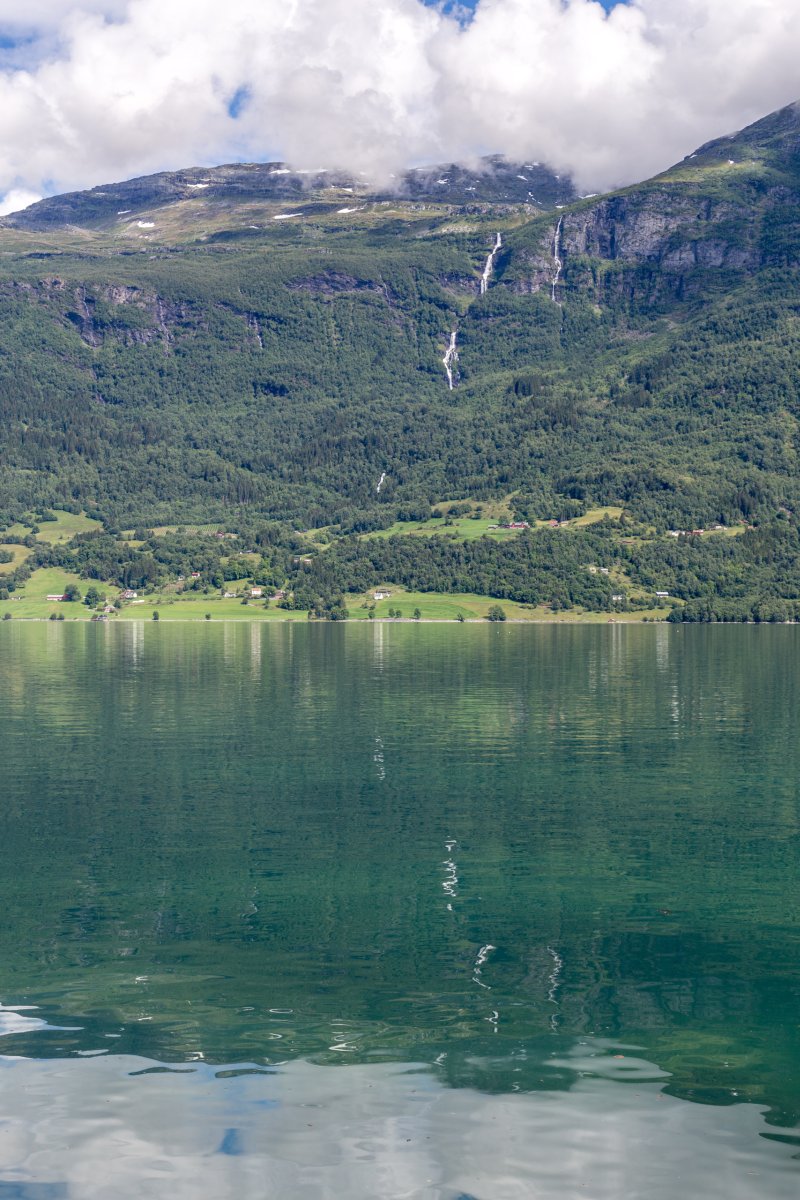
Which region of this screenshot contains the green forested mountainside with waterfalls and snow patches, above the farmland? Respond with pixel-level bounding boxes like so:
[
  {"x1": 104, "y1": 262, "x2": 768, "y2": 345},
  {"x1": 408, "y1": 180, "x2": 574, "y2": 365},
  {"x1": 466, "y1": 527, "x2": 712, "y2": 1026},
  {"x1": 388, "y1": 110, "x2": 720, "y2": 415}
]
[{"x1": 0, "y1": 106, "x2": 800, "y2": 619}]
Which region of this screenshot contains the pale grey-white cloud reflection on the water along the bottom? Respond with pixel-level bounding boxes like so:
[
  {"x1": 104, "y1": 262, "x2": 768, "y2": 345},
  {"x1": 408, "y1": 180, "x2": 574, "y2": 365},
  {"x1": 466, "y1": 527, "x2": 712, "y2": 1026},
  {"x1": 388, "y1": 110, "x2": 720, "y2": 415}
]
[{"x1": 0, "y1": 1046, "x2": 796, "y2": 1200}]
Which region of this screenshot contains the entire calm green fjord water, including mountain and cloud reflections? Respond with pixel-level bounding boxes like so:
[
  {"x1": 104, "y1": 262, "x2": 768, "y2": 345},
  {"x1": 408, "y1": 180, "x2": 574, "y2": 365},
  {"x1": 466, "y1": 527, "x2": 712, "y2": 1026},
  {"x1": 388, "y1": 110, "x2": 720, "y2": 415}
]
[{"x1": 0, "y1": 622, "x2": 800, "y2": 1200}]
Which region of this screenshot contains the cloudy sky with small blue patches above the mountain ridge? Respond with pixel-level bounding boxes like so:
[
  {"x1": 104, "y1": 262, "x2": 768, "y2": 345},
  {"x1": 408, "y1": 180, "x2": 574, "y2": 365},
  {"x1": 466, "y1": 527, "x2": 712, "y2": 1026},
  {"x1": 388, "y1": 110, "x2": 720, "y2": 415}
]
[{"x1": 0, "y1": 0, "x2": 800, "y2": 211}]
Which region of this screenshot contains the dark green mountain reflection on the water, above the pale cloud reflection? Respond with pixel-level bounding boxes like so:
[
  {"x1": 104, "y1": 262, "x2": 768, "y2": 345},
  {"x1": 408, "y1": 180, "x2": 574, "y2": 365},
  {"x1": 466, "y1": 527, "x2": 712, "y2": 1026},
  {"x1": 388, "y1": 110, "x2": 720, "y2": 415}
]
[{"x1": 0, "y1": 623, "x2": 800, "y2": 1115}]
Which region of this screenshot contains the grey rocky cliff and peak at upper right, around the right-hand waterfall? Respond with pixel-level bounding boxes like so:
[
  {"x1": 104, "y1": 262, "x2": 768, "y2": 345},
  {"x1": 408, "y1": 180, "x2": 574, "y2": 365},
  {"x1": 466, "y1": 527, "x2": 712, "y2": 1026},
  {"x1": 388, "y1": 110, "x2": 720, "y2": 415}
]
[{"x1": 499, "y1": 104, "x2": 800, "y2": 302}]
